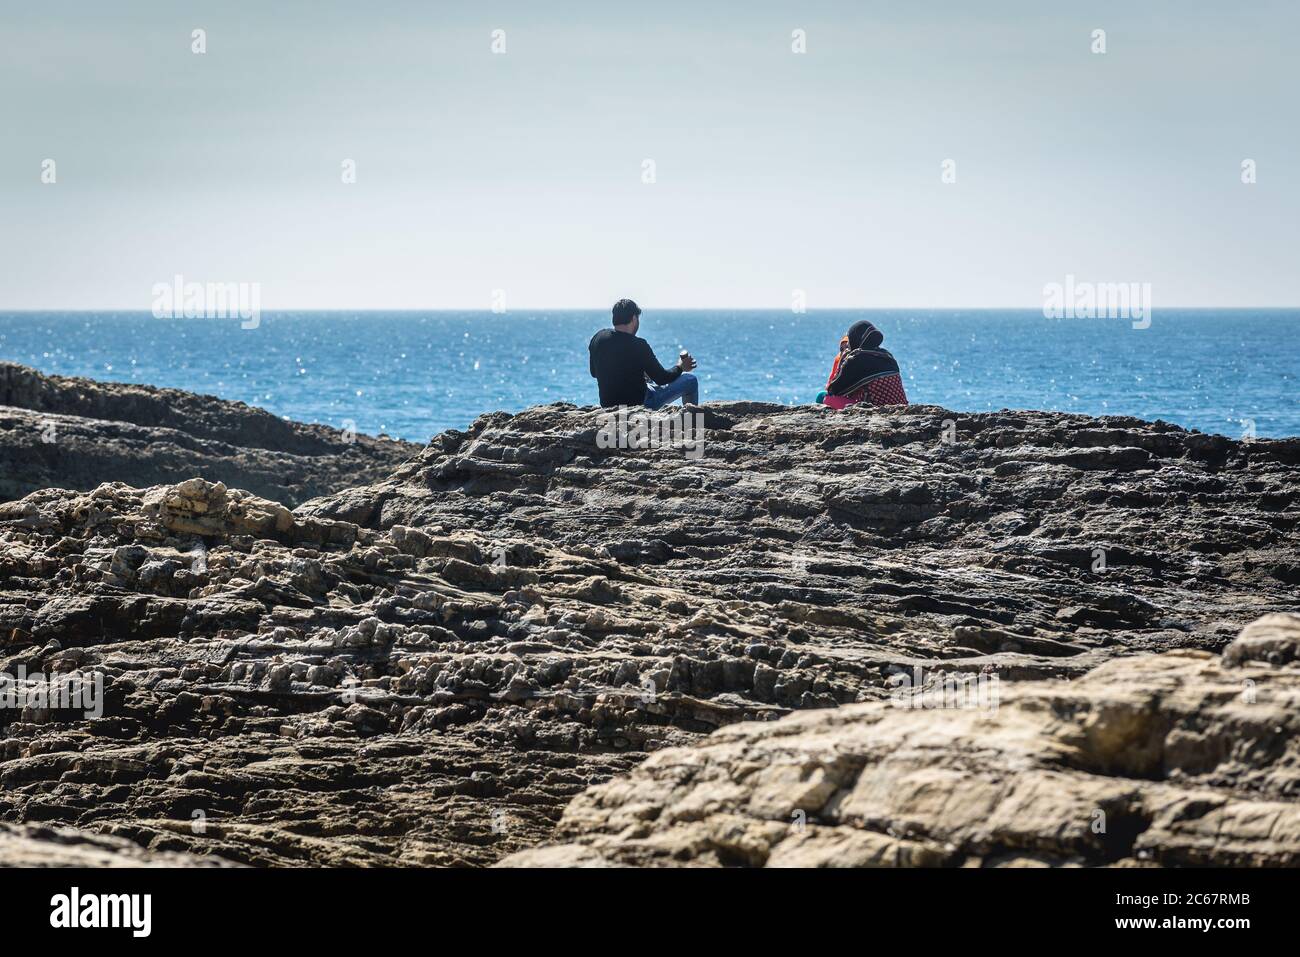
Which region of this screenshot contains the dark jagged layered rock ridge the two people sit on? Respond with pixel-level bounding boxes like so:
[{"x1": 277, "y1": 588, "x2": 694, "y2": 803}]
[{"x1": 0, "y1": 403, "x2": 1300, "y2": 865}]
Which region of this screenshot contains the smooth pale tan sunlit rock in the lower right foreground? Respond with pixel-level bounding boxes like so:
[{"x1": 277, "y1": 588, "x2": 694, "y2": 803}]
[{"x1": 504, "y1": 615, "x2": 1300, "y2": 867}]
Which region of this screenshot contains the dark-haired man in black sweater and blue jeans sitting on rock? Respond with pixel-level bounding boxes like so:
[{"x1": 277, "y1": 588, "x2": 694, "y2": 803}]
[{"x1": 586, "y1": 299, "x2": 699, "y2": 408}]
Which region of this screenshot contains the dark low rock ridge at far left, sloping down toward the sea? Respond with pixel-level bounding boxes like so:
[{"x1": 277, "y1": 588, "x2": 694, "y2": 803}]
[{"x1": 0, "y1": 363, "x2": 419, "y2": 506}]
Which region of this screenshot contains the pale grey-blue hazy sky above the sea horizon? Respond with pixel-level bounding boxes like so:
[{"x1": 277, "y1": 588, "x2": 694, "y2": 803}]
[{"x1": 0, "y1": 0, "x2": 1300, "y2": 311}]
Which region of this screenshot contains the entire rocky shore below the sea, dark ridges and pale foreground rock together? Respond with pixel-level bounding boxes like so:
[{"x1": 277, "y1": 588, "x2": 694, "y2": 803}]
[{"x1": 0, "y1": 367, "x2": 1300, "y2": 866}]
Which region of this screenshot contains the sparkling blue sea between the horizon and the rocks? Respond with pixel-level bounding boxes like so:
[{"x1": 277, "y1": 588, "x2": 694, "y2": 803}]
[{"x1": 0, "y1": 309, "x2": 1300, "y2": 442}]
